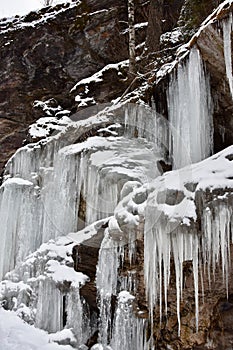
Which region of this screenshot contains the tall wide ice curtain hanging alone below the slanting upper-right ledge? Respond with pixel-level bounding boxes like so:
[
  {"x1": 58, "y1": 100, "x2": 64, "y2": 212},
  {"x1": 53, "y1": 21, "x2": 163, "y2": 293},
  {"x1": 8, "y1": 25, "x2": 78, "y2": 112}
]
[{"x1": 167, "y1": 48, "x2": 213, "y2": 169}]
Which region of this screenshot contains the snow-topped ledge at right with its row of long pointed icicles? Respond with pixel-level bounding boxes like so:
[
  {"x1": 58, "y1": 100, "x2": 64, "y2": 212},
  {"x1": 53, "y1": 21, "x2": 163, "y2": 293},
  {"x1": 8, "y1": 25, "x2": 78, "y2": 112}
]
[{"x1": 144, "y1": 147, "x2": 233, "y2": 336}]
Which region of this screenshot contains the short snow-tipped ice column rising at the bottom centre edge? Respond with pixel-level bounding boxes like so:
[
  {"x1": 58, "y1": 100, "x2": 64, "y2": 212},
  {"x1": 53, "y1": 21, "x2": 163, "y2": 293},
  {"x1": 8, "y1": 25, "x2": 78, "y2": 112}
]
[{"x1": 111, "y1": 291, "x2": 148, "y2": 350}]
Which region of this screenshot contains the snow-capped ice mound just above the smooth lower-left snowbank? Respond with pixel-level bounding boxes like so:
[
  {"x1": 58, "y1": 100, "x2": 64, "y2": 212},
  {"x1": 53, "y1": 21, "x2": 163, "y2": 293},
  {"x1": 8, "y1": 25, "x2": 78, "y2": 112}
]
[{"x1": 0, "y1": 237, "x2": 92, "y2": 346}]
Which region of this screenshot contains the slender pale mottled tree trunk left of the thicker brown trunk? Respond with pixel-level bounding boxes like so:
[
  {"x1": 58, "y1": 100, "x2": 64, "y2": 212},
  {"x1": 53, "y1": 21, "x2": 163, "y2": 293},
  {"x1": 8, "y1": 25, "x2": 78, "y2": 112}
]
[{"x1": 128, "y1": 0, "x2": 136, "y2": 78}]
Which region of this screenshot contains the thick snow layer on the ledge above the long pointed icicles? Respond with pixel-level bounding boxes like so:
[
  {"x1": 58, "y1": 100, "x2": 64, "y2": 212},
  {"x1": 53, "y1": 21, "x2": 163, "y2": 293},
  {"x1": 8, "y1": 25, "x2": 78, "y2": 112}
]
[{"x1": 115, "y1": 146, "x2": 233, "y2": 227}]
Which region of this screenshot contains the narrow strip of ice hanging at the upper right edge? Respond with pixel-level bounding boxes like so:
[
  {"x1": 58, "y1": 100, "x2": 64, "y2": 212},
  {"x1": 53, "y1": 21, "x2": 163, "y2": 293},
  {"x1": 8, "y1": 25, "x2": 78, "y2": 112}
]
[{"x1": 223, "y1": 13, "x2": 233, "y2": 98}]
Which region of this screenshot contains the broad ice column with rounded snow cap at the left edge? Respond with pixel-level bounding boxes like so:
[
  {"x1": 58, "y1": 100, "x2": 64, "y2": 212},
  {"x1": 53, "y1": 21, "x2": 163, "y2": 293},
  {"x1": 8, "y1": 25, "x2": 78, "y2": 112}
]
[{"x1": 0, "y1": 178, "x2": 41, "y2": 279}]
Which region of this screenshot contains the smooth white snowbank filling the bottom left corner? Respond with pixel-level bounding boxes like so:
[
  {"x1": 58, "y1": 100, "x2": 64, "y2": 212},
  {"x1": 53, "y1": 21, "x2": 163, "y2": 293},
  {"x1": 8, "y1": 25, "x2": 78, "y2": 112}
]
[{"x1": 0, "y1": 308, "x2": 73, "y2": 350}]
